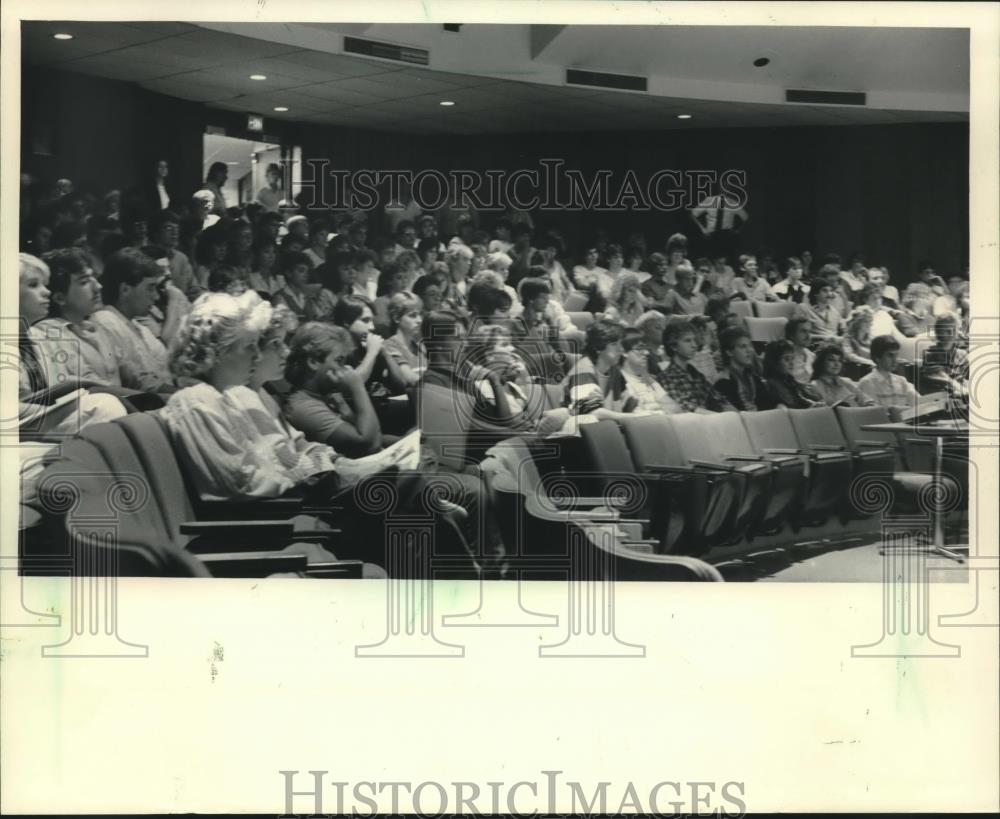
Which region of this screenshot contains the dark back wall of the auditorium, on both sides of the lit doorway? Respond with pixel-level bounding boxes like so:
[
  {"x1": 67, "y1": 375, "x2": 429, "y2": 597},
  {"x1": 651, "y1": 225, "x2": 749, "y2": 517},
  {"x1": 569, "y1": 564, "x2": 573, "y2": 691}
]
[{"x1": 22, "y1": 68, "x2": 969, "y2": 282}]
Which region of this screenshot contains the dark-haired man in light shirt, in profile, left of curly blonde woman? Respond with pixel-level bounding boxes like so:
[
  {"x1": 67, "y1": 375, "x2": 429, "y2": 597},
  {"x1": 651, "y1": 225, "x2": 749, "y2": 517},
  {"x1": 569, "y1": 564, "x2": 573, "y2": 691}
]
[{"x1": 92, "y1": 248, "x2": 176, "y2": 393}]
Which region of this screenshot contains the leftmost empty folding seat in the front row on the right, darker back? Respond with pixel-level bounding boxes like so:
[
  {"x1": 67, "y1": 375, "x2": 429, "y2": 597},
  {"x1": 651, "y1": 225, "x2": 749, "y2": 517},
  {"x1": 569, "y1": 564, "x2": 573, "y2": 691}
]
[{"x1": 580, "y1": 420, "x2": 698, "y2": 553}]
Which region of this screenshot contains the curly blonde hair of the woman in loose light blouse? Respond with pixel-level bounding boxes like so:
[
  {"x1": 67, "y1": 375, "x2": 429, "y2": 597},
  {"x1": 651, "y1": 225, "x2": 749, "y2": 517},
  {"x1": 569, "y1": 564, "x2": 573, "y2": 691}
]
[{"x1": 170, "y1": 290, "x2": 273, "y2": 381}]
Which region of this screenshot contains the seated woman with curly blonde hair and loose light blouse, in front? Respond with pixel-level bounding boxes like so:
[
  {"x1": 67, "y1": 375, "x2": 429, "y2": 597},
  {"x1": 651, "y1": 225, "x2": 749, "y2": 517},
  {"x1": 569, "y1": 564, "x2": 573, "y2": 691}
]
[{"x1": 162, "y1": 292, "x2": 472, "y2": 562}]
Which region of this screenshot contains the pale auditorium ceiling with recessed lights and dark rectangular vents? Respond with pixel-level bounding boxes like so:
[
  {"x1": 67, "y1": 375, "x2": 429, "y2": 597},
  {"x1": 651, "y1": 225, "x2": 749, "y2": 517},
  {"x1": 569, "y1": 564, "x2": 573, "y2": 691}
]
[{"x1": 22, "y1": 21, "x2": 969, "y2": 134}]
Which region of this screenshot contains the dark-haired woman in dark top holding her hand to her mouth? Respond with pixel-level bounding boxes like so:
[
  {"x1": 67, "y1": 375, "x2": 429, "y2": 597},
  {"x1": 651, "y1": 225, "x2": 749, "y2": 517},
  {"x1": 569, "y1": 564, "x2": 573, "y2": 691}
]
[{"x1": 332, "y1": 296, "x2": 414, "y2": 435}]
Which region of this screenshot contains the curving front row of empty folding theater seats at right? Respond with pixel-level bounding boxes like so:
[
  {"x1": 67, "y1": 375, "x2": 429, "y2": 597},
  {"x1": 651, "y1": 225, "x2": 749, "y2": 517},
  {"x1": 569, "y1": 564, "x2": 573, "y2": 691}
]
[{"x1": 491, "y1": 407, "x2": 967, "y2": 561}]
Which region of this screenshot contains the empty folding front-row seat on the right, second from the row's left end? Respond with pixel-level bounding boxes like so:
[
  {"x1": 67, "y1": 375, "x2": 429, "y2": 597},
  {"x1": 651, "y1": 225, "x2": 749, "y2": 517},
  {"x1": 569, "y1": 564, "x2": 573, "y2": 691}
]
[{"x1": 618, "y1": 415, "x2": 743, "y2": 554}]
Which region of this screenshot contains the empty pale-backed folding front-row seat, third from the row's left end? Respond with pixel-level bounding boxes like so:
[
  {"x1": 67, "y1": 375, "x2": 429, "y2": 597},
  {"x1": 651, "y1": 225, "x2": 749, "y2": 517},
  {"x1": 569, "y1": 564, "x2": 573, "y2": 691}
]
[{"x1": 671, "y1": 412, "x2": 804, "y2": 539}]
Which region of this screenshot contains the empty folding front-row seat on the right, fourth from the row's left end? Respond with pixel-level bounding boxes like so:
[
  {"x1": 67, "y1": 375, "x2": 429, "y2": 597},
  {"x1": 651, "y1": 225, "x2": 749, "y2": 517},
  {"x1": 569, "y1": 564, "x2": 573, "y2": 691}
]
[{"x1": 740, "y1": 409, "x2": 853, "y2": 525}]
